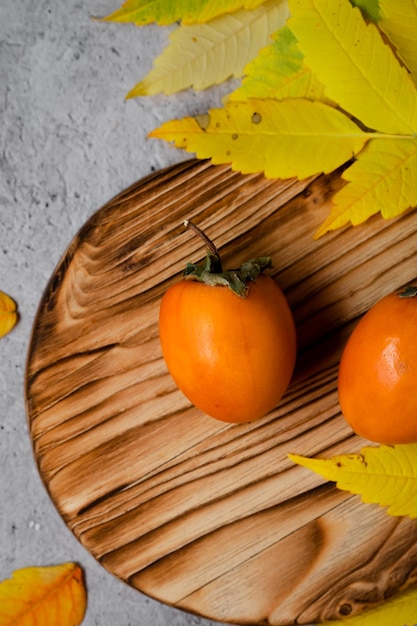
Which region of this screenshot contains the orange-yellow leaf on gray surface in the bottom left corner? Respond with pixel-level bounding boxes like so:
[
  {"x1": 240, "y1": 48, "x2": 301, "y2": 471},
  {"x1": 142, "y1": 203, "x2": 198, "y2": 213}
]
[{"x1": 0, "y1": 563, "x2": 86, "y2": 626}]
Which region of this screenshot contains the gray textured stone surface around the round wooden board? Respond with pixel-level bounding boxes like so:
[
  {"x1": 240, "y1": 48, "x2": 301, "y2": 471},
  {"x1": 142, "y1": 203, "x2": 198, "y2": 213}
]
[{"x1": 0, "y1": 0, "x2": 232, "y2": 626}]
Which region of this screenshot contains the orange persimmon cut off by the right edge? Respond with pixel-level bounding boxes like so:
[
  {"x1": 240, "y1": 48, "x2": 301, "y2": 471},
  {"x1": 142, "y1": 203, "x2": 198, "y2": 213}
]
[{"x1": 338, "y1": 287, "x2": 417, "y2": 444}]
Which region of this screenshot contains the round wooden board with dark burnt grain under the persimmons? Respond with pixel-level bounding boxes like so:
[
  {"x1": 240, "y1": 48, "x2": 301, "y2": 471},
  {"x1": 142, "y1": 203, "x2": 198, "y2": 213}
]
[{"x1": 26, "y1": 160, "x2": 417, "y2": 626}]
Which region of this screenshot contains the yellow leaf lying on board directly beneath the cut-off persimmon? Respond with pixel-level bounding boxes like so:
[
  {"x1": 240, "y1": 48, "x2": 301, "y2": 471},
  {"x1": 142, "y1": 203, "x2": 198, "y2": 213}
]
[{"x1": 289, "y1": 444, "x2": 417, "y2": 518}]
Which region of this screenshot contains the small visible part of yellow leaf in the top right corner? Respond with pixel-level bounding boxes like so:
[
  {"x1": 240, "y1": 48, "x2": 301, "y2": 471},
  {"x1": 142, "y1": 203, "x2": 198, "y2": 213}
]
[{"x1": 379, "y1": 0, "x2": 417, "y2": 83}]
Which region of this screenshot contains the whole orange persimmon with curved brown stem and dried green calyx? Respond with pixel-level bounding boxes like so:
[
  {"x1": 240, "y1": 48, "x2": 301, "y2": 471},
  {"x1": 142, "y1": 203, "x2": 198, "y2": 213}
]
[{"x1": 159, "y1": 222, "x2": 296, "y2": 423}]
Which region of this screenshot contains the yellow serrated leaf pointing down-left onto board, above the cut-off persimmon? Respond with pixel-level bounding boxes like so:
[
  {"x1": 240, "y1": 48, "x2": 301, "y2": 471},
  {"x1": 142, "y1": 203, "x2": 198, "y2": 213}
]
[{"x1": 316, "y1": 138, "x2": 417, "y2": 237}]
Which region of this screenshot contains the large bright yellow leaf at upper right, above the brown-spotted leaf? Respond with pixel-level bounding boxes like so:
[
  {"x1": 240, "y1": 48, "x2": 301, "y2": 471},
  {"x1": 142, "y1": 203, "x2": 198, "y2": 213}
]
[{"x1": 288, "y1": 0, "x2": 417, "y2": 135}]
